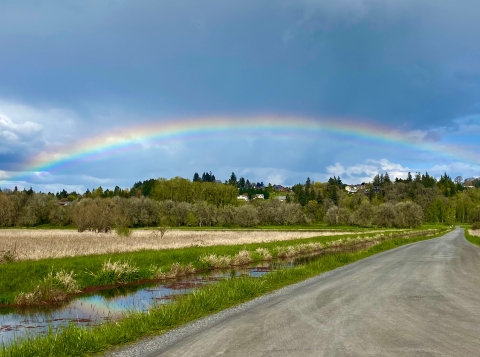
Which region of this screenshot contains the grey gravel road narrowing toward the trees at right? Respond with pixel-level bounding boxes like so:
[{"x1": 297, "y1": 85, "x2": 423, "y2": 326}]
[{"x1": 107, "y1": 228, "x2": 480, "y2": 357}]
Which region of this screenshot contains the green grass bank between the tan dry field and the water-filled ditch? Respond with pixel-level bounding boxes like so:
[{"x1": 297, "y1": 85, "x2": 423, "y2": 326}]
[{"x1": 0, "y1": 228, "x2": 445, "y2": 304}]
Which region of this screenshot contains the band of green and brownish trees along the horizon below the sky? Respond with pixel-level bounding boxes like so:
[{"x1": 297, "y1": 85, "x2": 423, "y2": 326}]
[{"x1": 0, "y1": 173, "x2": 480, "y2": 231}]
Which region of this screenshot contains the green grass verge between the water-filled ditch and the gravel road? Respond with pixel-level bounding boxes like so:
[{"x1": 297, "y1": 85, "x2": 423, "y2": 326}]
[{"x1": 0, "y1": 231, "x2": 445, "y2": 357}]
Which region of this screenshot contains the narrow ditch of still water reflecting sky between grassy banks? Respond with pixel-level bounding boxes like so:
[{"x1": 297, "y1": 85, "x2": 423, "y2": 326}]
[{"x1": 0, "y1": 255, "x2": 321, "y2": 346}]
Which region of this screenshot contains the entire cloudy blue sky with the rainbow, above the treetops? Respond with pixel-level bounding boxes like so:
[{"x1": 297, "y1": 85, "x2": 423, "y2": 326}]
[{"x1": 0, "y1": 0, "x2": 480, "y2": 192}]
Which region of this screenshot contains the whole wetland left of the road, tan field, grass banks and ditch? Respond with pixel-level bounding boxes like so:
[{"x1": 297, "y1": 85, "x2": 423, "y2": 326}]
[{"x1": 0, "y1": 226, "x2": 449, "y2": 357}]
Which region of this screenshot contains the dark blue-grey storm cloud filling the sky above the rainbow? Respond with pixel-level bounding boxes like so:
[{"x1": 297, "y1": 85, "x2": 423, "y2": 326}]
[{"x1": 0, "y1": 0, "x2": 480, "y2": 129}]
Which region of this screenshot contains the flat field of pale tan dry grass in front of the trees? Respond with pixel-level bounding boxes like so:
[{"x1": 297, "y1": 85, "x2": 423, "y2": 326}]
[{"x1": 0, "y1": 229, "x2": 376, "y2": 260}]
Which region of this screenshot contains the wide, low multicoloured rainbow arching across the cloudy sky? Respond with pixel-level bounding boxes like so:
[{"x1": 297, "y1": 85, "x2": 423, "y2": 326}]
[{"x1": 5, "y1": 116, "x2": 478, "y2": 179}]
